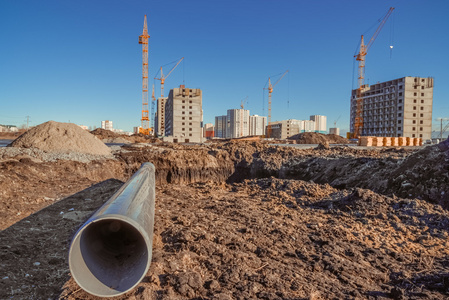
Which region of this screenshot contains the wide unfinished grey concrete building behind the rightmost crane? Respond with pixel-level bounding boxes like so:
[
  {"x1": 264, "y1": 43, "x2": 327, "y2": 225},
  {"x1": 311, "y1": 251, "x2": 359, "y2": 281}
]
[{"x1": 350, "y1": 77, "x2": 434, "y2": 140}]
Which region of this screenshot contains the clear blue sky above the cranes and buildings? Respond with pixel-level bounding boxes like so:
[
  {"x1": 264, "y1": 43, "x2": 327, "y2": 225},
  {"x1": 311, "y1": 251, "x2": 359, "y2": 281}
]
[{"x1": 0, "y1": 0, "x2": 449, "y2": 131}]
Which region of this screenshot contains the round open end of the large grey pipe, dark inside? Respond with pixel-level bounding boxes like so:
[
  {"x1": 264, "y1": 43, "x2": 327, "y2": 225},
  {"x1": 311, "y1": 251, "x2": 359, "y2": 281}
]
[{"x1": 69, "y1": 219, "x2": 149, "y2": 296}]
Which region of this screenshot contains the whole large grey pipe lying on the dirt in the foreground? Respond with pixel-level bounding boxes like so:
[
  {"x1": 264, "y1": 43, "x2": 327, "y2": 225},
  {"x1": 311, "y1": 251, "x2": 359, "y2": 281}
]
[{"x1": 69, "y1": 163, "x2": 155, "y2": 297}]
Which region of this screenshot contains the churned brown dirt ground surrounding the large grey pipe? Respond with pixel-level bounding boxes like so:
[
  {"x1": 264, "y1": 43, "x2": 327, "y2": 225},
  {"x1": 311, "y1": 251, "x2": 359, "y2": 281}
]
[{"x1": 0, "y1": 132, "x2": 449, "y2": 299}]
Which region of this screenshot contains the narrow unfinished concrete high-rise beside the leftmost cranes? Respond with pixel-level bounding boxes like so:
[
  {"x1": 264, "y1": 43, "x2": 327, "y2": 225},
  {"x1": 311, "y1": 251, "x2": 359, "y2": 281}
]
[{"x1": 164, "y1": 85, "x2": 203, "y2": 143}]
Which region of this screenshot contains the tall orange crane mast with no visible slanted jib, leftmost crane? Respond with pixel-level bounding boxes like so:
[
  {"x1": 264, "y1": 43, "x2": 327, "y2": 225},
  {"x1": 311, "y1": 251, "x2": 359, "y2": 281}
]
[{"x1": 139, "y1": 15, "x2": 150, "y2": 135}]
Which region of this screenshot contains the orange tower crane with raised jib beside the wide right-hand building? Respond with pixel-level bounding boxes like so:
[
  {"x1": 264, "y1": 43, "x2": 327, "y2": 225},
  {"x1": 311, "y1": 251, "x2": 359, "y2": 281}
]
[{"x1": 352, "y1": 7, "x2": 394, "y2": 138}]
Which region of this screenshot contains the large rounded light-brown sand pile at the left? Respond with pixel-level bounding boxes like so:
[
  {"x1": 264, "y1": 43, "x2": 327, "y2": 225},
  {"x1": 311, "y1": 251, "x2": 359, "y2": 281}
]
[{"x1": 8, "y1": 121, "x2": 111, "y2": 155}]
